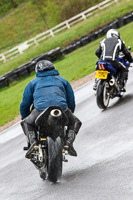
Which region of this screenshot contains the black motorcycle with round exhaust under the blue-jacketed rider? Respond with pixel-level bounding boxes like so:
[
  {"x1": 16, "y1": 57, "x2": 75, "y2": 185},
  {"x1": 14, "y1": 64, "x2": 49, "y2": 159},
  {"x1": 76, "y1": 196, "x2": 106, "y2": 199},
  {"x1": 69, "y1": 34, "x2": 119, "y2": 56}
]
[{"x1": 24, "y1": 106, "x2": 68, "y2": 183}]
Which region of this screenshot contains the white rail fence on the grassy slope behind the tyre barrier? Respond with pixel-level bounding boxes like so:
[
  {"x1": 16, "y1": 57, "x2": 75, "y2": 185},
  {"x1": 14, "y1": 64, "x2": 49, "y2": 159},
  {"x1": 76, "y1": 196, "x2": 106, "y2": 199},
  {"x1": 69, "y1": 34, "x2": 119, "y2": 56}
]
[{"x1": 0, "y1": 0, "x2": 118, "y2": 62}]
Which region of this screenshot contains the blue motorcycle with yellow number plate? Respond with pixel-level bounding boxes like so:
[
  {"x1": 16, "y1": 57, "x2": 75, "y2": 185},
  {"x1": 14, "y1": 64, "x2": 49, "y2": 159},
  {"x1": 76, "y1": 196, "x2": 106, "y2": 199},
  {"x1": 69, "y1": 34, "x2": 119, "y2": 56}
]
[{"x1": 95, "y1": 48, "x2": 131, "y2": 109}]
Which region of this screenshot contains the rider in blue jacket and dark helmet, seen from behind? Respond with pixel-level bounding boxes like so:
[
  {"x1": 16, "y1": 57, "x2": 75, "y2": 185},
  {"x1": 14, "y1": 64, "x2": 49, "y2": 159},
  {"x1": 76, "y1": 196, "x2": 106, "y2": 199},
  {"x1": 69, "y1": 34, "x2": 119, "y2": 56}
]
[{"x1": 20, "y1": 60, "x2": 81, "y2": 158}]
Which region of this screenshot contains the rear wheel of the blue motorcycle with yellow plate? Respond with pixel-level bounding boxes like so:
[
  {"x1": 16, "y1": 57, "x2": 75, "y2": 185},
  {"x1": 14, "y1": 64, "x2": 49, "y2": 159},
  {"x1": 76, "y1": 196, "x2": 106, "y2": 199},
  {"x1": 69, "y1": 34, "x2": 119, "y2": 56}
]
[{"x1": 96, "y1": 80, "x2": 110, "y2": 109}]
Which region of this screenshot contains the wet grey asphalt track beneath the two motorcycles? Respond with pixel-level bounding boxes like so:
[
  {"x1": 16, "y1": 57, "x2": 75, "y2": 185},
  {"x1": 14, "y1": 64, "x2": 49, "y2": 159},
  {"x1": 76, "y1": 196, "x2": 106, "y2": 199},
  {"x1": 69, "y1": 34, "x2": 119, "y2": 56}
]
[{"x1": 0, "y1": 70, "x2": 133, "y2": 200}]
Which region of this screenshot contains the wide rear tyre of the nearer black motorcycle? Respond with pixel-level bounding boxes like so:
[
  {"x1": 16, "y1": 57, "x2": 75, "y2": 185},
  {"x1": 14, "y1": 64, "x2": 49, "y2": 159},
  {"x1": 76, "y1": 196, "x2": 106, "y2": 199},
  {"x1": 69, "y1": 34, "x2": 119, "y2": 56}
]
[{"x1": 47, "y1": 137, "x2": 62, "y2": 183}]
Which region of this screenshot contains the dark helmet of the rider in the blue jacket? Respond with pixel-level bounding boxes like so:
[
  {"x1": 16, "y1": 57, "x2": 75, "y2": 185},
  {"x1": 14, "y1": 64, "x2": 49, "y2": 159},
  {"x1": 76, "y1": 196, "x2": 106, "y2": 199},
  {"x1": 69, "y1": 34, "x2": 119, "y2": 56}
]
[{"x1": 35, "y1": 60, "x2": 55, "y2": 72}]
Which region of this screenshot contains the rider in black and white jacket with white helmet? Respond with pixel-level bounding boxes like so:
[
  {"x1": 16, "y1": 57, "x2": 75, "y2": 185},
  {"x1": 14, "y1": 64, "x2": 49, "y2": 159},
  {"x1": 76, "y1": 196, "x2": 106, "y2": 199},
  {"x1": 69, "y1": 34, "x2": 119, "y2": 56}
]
[{"x1": 93, "y1": 29, "x2": 133, "y2": 90}]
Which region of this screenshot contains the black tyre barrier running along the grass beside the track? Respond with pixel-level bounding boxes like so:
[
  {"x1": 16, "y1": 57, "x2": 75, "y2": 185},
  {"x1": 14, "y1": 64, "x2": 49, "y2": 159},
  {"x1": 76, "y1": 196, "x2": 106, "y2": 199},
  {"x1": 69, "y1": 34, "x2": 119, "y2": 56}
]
[{"x1": 0, "y1": 12, "x2": 133, "y2": 88}]
